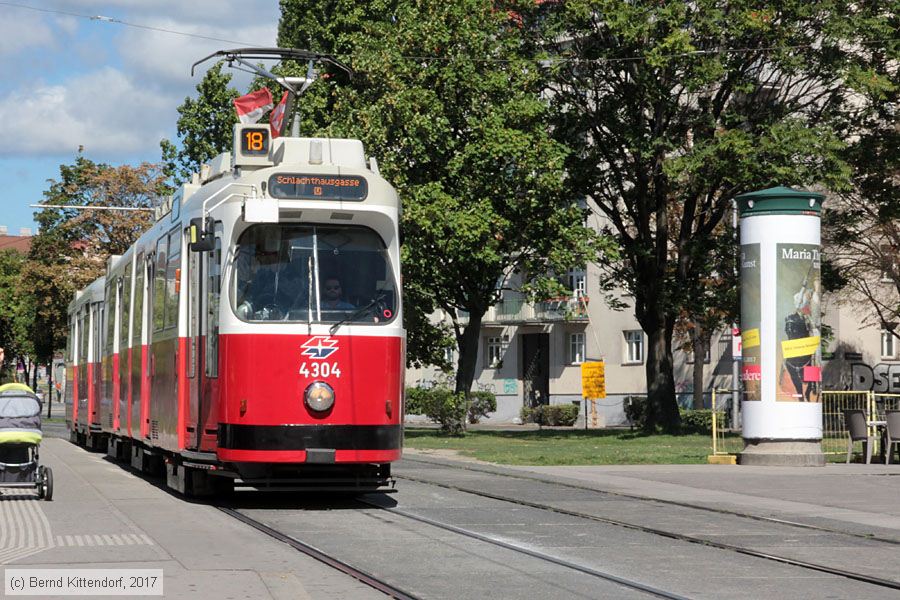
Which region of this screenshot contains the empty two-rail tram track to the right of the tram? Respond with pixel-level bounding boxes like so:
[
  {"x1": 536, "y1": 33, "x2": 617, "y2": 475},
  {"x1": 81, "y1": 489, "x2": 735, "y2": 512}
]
[{"x1": 395, "y1": 459, "x2": 900, "y2": 590}]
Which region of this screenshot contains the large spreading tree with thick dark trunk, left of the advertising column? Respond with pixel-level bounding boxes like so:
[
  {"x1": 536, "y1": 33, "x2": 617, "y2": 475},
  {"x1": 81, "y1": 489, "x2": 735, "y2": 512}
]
[{"x1": 543, "y1": 0, "x2": 896, "y2": 430}]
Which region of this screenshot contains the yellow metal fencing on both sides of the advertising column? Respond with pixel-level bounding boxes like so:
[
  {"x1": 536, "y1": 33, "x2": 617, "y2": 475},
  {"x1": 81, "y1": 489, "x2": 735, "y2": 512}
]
[{"x1": 712, "y1": 390, "x2": 900, "y2": 455}]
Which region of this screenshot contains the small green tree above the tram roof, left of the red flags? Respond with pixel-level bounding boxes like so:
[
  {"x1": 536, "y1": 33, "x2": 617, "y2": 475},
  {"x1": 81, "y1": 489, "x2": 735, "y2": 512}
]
[{"x1": 159, "y1": 62, "x2": 239, "y2": 185}]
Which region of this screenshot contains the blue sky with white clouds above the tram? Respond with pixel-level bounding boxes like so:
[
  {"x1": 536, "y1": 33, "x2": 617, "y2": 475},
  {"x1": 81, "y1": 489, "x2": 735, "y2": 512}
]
[{"x1": 0, "y1": 0, "x2": 280, "y2": 235}]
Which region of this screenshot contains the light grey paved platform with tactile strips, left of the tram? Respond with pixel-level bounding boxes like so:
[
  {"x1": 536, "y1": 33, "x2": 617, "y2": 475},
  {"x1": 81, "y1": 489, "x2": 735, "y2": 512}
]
[{"x1": 0, "y1": 437, "x2": 384, "y2": 600}]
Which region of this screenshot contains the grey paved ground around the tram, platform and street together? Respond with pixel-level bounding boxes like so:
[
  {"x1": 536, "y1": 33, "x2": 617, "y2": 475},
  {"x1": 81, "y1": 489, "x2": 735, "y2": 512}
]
[{"x1": 7, "y1": 422, "x2": 900, "y2": 600}]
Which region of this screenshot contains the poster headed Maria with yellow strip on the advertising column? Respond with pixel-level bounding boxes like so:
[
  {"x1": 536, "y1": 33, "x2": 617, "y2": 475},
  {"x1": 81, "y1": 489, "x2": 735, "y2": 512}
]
[{"x1": 775, "y1": 244, "x2": 822, "y2": 402}]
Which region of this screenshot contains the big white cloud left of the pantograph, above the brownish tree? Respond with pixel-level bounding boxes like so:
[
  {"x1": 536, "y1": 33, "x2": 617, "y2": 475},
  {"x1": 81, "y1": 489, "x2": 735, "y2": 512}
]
[{"x1": 0, "y1": 68, "x2": 174, "y2": 156}]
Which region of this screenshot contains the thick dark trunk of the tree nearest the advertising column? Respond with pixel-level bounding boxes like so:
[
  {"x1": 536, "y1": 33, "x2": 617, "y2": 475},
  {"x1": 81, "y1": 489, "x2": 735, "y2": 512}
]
[{"x1": 645, "y1": 325, "x2": 681, "y2": 433}]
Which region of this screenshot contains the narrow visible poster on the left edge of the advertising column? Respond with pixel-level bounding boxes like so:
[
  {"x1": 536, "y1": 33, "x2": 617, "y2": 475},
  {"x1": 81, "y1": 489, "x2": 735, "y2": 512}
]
[{"x1": 741, "y1": 244, "x2": 762, "y2": 400}]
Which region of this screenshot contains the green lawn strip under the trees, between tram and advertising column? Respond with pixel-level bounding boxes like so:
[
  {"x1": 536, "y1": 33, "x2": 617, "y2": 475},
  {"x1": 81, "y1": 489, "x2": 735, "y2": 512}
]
[{"x1": 405, "y1": 427, "x2": 739, "y2": 466}]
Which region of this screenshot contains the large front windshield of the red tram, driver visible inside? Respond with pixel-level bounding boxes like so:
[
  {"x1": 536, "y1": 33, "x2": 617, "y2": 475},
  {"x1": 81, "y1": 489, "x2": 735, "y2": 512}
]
[{"x1": 230, "y1": 225, "x2": 397, "y2": 324}]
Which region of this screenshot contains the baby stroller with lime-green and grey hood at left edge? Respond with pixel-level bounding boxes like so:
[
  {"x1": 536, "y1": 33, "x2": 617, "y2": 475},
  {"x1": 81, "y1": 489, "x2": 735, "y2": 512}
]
[{"x1": 0, "y1": 383, "x2": 53, "y2": 500}]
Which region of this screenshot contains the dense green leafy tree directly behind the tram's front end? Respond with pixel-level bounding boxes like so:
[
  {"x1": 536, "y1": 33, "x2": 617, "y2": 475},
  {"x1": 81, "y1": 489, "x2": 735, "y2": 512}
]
[{"x1": 279, "y1": 0, "x2": 597, "y2": 392}]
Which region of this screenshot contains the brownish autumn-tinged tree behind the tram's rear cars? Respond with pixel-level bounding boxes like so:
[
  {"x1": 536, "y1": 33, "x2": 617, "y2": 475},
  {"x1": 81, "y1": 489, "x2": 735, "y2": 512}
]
[{"x1": 21, "y1": 154, "x2": 163, "y2": 364}]
